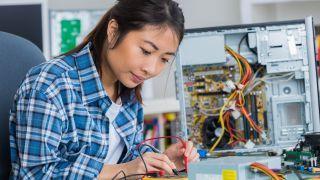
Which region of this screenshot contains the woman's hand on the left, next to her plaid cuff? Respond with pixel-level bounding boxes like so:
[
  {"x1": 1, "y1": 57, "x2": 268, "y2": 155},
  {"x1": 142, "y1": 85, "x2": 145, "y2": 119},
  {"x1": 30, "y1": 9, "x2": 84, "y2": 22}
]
[{"x1": 127, "y1": 152, "x2": 176, "y2": 175}]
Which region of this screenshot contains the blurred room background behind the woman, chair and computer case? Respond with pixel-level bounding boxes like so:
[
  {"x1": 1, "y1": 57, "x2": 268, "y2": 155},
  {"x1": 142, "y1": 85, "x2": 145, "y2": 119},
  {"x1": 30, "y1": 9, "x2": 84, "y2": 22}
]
[{"x1": 0, "y1": 0, "x2": 320, "y2": 150}]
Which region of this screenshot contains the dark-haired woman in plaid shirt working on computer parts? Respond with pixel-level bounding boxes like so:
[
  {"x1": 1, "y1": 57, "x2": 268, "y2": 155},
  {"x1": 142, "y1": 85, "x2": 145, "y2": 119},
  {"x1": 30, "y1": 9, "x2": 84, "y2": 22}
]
[{"x1": 10, "y1": 0, "x2": 198, "y2": 179}]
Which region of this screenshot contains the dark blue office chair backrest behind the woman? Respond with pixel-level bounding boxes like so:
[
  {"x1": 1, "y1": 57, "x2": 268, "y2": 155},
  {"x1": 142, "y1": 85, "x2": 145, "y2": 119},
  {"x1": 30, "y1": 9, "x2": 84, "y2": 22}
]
[{"x1": 0, "y1": 31, "x2": 45, "y2": 179}]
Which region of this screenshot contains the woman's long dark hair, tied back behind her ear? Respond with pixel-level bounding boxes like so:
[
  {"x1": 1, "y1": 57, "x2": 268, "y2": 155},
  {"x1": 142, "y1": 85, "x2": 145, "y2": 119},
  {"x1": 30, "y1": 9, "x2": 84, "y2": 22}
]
[{"x1": 64, "y1": 0, "x2": 184, "y2": 103}]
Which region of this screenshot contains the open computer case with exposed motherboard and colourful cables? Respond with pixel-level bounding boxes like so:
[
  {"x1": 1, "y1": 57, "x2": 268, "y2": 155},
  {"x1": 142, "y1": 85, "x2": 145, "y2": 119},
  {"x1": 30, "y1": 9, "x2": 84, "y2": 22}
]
[{"x1": 176, "y1": 17, "x2": 320, "y2": 152}]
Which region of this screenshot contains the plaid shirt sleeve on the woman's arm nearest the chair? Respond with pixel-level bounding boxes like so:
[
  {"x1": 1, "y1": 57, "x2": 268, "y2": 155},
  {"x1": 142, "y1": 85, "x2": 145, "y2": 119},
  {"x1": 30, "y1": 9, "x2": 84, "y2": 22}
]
[{"x1": 10, "y1": 90, "x2": 103, "y2": 179}]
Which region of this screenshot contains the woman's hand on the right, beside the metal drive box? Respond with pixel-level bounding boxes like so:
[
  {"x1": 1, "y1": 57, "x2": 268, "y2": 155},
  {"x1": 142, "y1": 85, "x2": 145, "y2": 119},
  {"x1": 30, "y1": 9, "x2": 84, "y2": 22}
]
[{"x1": 164, "y1": 141, "x2": 199, "y2": 170}]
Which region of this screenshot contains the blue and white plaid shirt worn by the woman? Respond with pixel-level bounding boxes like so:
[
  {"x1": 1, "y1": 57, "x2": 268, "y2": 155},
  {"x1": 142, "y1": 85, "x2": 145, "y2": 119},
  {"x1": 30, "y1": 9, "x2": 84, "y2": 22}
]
[{"x1": 10, "y1": 43, "x2": 150, "y2": 179}]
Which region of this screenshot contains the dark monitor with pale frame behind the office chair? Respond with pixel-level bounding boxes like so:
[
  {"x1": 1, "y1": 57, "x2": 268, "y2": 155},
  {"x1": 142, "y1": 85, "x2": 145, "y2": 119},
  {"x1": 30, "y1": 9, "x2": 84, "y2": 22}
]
[{"x1": 0, "y1": 0, "x2": 49, "y2": 57}]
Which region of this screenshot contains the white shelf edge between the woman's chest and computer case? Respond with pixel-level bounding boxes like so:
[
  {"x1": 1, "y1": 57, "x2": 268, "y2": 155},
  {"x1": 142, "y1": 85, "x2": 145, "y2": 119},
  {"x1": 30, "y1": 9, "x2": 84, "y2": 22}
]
[{"x1": 143, "y1": 98, "x2": 180, "y2": 115}]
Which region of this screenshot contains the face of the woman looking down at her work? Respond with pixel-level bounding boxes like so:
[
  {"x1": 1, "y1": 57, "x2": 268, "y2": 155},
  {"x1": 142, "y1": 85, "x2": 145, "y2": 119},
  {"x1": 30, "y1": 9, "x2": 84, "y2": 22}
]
[{"x1": 106, "y1": 25, "x2": 179, "y2": 88}]
